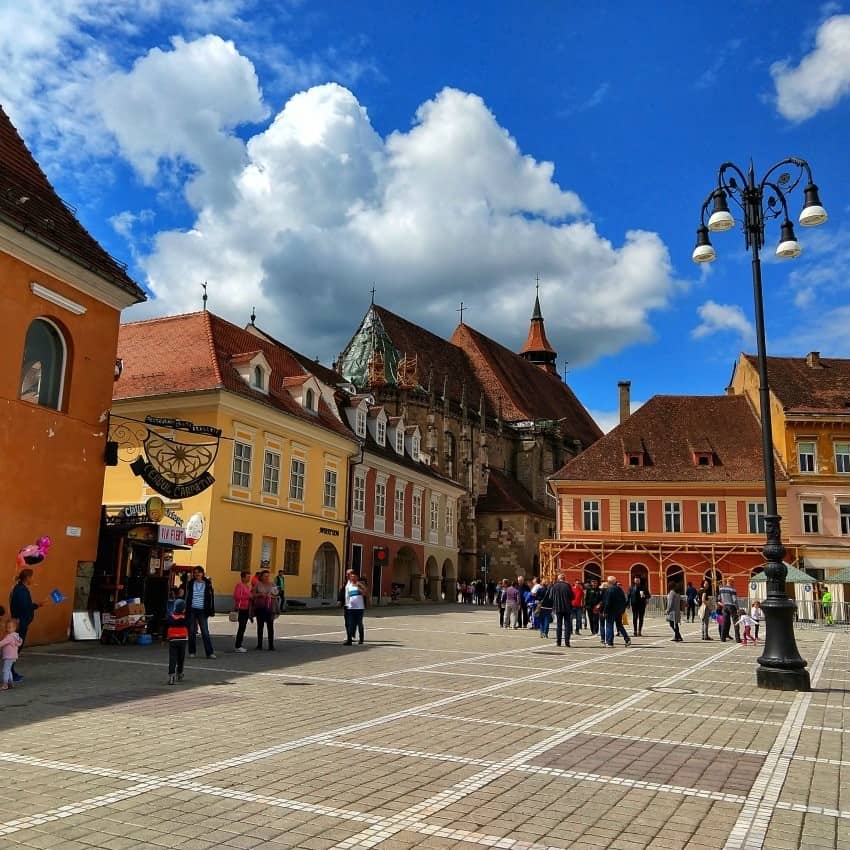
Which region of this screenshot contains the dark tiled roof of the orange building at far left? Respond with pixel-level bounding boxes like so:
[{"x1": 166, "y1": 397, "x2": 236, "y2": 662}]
[{"x1": 0, "y1": 107, "x2": 146, "y2": 301}]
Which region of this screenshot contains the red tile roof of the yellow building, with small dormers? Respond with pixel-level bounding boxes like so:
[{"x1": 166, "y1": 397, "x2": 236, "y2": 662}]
[{"x1": 112, "y1": 312, "x2": 353, "y2": 440}]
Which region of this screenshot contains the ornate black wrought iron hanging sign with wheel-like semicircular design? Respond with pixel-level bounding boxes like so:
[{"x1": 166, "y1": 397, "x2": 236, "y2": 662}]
[{"x1": 107, "y1": 416, "x2": 221, "y2": 499}]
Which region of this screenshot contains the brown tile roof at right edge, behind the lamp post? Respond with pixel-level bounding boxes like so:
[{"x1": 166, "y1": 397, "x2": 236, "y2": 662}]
[{"x1": 742, "y1": 354, "x2": 850, "y2": 414}]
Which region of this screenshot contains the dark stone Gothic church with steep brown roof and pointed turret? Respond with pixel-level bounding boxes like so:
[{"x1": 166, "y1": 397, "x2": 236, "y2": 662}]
[{"x1": 337, "y1": 300, "x2": 601, "y2": 578}]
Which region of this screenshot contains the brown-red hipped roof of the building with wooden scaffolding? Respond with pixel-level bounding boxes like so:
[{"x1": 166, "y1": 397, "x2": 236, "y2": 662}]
[{"x1": 551, "y1": 395, "x2": 787, "y2": 482}]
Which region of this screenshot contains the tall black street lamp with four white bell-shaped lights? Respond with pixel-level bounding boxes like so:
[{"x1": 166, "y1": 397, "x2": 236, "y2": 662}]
[{"x1": 693, "y1": 157, "x2": 827, "y2": 691}]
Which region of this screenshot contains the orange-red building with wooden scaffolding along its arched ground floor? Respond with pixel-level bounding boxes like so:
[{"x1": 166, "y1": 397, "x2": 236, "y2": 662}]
[{"x1": 541, "y1": 395, "x2": 797, "y2": 594}]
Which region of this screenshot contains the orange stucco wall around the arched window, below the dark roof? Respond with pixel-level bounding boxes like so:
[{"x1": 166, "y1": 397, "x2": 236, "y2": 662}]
[{"x1": 0, "y1": 253, "x2": 120, "y2": 643}]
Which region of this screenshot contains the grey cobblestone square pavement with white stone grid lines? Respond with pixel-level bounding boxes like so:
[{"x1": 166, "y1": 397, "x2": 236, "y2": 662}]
[{"x1": 0, "y1": 606, "x2": 850, "y2": 850}]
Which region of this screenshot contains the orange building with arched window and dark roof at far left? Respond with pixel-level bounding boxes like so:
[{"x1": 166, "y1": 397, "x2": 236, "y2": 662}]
[{"x1": 0, "y1": 109, "x2": 145, "y2": 643}]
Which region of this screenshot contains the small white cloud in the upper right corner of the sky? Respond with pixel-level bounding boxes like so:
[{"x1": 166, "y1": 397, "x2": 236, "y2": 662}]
[{"x1": 770, "y1": 15, "x2": 850, "y2": 121}]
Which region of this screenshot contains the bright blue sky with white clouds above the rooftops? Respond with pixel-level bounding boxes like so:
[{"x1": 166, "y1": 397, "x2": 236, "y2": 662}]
[{"x1": 0, "y1": 0, "x2": 850, "y2": 425}]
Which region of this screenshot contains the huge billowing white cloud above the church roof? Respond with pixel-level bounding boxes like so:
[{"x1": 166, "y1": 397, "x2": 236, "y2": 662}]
[{"x1": 128, "y1": 84, "x2": 675, "y2": 365}]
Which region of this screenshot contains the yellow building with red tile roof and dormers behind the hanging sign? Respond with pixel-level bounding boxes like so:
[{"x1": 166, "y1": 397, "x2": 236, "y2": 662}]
[{"x1": 103, "y1": 311, "x2": 359, "y2": 607}]
